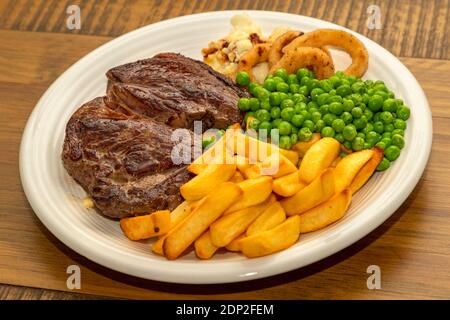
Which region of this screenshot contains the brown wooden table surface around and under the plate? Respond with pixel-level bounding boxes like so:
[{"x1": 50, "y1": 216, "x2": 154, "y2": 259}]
[{"x1": 0, "y1": 0, "x2": 450, "y2": 299}]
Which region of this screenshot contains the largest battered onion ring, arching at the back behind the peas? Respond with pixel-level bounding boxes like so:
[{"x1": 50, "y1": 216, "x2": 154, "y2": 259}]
[{"x1": 283, "y1": 29, "x2": 369, "y2": 77}]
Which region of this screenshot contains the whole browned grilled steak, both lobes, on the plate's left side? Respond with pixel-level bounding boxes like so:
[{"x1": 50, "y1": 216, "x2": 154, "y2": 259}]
[{"x1": 62, "y1": 53, "x2": 244, "y2": 218}]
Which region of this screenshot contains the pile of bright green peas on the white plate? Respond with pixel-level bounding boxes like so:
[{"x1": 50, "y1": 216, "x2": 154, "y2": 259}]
[{"x1": 236, "y1": 68, "x2": 410, "y2": 171}]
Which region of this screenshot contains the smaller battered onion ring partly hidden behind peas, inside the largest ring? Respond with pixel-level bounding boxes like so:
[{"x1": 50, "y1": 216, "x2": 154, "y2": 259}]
[{"x1": 269, "y1": 47, "x2": 334, "y2": 79}]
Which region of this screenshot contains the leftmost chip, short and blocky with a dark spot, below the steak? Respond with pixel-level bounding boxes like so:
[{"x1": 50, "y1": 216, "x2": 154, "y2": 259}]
[{"x1": 120, "y1": 210, "x2": 170, "y2": 240}]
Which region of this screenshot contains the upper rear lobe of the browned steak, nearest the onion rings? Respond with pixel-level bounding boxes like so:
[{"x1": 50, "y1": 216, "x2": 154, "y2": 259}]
[{"x1": 106, "y1": 53, "x2": 248, "y2": 129}]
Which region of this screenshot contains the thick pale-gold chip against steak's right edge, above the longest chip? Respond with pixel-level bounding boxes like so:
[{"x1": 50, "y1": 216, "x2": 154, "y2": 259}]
[{"x1": 180, "y1": 163, "x2": 236, "y2": 201}]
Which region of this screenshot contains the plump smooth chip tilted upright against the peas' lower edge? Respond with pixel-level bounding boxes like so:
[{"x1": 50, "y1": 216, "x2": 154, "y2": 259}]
[{"x1": 298, "y1": 137, "x2": 340, "y2": 184}]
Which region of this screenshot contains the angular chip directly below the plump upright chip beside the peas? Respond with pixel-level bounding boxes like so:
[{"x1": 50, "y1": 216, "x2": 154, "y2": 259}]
[{"x1": 280, "y1": 169, "x2": 335, "y2": 216}]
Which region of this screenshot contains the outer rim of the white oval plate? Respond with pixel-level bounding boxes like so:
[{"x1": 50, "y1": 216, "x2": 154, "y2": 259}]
[{"x1": 19, "y1": 10, "x2": 433, "y2": 284}]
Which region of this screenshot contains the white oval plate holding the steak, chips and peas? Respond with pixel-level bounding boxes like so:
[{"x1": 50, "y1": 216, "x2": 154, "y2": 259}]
[{"x1": 20, "y1": 11, "x2": 432, "y2": 283}]
